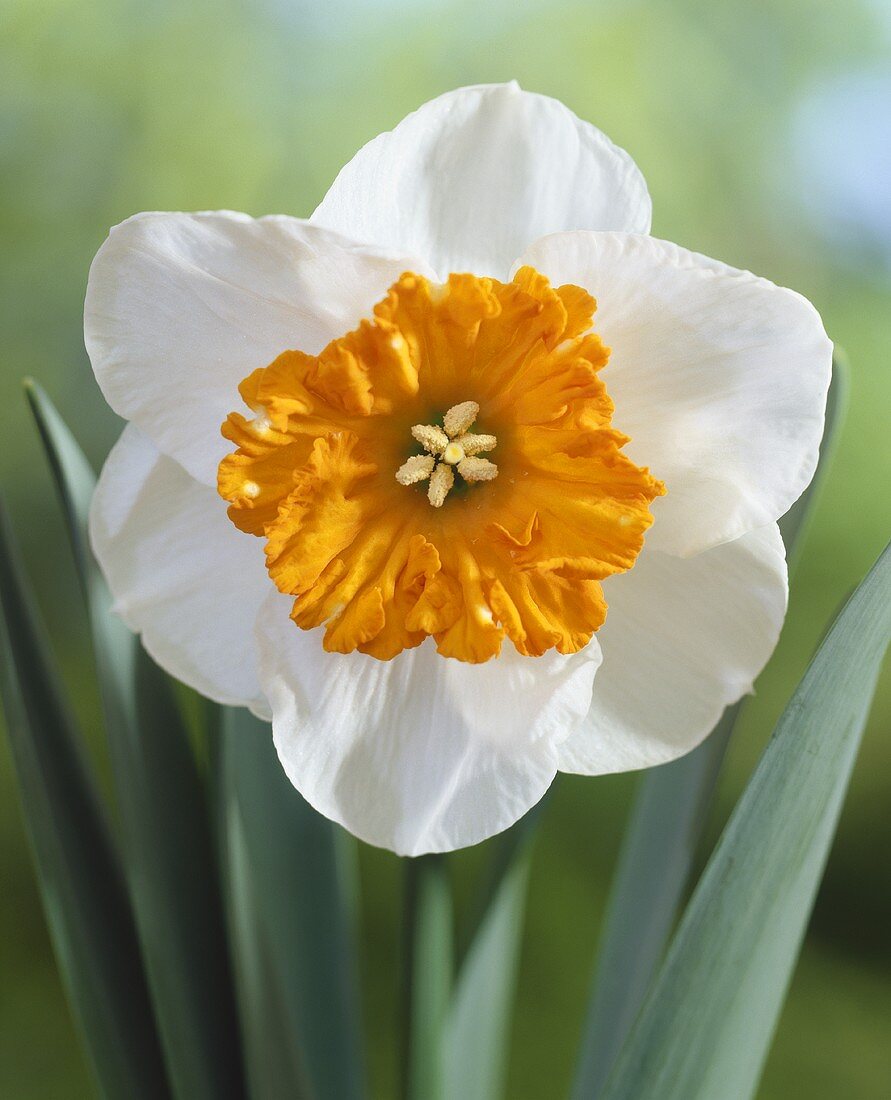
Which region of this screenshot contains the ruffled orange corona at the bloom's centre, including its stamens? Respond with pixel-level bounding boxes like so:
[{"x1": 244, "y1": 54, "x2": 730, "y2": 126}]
[{"x1": 219, "y1": 267, "x2": 664, "y2": 662}]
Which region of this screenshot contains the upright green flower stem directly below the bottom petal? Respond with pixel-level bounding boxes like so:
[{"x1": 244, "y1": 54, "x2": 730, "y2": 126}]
[{"x1": 403, "y1": 856, "x2": 452, "y2": 1100}]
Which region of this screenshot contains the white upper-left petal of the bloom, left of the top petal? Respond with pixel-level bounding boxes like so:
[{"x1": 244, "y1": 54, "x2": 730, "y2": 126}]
[{"x1": 84, "y1": 212, "x2": 425, "y2": 485}]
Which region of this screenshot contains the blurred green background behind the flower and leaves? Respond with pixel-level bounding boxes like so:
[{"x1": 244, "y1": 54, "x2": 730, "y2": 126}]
[{"x1": 0, "y1": 0, "x2": 891, "y2": 1100}]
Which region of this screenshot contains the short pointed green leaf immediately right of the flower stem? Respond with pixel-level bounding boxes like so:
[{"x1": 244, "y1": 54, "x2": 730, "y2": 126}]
[{"x1": 444, "y1": 831, "x2": 537, "y2": 1100}]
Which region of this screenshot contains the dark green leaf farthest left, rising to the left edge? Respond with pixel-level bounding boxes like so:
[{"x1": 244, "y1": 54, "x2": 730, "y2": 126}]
[{"x1": 0, "y1": 502, "x2": 169, "y2": 1100}]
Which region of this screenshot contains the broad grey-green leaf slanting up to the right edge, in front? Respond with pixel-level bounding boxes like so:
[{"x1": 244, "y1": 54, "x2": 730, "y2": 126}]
[{"x1": 603, "y1": 548, "x2": 891, "y2": 1100}]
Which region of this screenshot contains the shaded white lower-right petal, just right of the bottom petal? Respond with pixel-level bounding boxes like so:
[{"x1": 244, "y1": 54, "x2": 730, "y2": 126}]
[{"x1": 559, "y1": 524, "x2": 788, "y2": 776}]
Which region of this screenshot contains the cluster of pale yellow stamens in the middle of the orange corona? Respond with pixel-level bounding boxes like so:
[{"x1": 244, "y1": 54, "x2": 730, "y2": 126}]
[{"x1": 396, "y1": 402, "x2": 498, "y2": 508}]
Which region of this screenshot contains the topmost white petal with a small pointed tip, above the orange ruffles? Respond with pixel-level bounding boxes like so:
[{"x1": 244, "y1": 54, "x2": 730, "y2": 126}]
[{"x1": 312, "y1": 83, "x2": 651, "y2": 278}]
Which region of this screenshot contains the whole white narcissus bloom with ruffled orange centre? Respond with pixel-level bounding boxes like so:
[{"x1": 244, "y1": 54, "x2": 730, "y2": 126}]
[{"x1": 85, "y1": 85, "x2": 832, "y2": 855}]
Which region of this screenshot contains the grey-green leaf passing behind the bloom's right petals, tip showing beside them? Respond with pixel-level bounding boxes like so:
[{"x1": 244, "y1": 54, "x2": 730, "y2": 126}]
[{"x1": 572, "y1": 352, "x2": 848, "y2": 1100}]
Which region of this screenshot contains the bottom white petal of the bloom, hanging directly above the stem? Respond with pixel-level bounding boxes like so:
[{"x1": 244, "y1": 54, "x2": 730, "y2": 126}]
[{"x1": 253, "y1": 594, "x2": 600, "y2": 856}]
